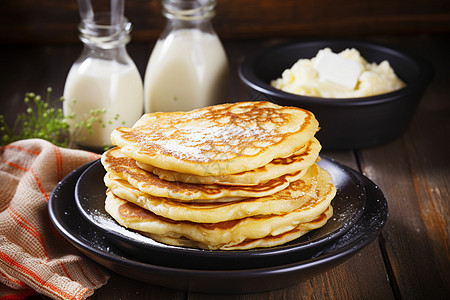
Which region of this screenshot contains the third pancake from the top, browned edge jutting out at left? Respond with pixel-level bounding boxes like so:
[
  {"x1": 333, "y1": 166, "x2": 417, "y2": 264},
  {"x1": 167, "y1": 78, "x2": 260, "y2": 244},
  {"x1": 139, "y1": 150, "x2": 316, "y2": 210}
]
[{"x1": 101, "y1": 147, "x2": 306, "y2": 202}]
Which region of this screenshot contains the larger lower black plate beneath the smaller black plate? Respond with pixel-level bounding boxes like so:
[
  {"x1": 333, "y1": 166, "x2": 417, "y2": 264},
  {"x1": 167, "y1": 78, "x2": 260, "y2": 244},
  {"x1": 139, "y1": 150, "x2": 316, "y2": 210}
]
[{"x1": 48, "y1": 164, "x2": 387, "y2": 294}]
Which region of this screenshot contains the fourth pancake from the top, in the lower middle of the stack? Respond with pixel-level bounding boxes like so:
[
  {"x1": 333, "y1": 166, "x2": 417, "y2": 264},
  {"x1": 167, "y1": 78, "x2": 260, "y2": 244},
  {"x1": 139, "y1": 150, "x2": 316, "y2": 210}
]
[{"x1": 105, "y1": 165, "x2": 322, "y2": 223}]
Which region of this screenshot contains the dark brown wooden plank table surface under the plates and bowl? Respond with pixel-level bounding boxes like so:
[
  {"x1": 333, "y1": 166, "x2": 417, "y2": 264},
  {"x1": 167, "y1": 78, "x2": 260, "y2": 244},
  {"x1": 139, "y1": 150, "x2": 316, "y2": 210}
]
[{"x1": 0, "y1": 35, "x2": 450, "y2": 299}]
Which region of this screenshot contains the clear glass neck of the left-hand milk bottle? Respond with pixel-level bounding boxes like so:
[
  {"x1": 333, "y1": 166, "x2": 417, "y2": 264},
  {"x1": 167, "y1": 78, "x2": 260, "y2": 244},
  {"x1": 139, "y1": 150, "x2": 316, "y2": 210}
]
[{"x1": 78, "y1": 12, "x2": 132, "y2": 50}]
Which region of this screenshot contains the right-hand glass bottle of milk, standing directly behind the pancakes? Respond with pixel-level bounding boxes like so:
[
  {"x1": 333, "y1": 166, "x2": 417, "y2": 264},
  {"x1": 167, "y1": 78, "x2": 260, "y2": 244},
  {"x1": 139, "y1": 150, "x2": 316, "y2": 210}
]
[{"x1": 144, "y1": 0, "x2": 228, "y2": 113}]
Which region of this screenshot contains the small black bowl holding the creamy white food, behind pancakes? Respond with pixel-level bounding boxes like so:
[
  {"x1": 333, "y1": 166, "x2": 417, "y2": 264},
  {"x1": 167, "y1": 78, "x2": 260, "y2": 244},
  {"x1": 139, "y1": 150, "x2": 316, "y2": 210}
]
[{"x1": 239, "y1": 39, "x2": 433, "y2": 150}]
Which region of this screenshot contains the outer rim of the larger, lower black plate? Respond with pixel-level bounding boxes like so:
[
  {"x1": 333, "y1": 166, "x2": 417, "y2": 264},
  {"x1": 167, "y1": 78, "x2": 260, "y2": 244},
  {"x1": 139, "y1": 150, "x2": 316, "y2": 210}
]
[{"x1": 48, "y1": 159, "x2": 388, "y2": 294}]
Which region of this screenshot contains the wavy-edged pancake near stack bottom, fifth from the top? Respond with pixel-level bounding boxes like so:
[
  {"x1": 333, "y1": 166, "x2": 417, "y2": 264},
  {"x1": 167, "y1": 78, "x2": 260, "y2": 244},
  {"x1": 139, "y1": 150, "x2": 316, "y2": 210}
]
[{"x1": 105, "y1": 164, "x2": 336, "y2": 249}]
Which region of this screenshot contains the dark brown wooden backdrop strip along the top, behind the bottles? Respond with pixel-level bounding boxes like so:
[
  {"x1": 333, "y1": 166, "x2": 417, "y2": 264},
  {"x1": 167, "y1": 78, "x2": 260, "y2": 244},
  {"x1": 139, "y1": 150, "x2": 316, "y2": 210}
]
[{"x1": 0, "y1": 0, "x2": 450, "y2": 44}]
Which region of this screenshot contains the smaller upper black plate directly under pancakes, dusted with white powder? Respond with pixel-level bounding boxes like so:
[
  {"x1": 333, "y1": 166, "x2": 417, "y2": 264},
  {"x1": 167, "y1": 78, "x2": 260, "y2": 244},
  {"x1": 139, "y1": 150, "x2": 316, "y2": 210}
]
[{"x1": 75, "y1": 158, "x2": 366, "y2": 270}]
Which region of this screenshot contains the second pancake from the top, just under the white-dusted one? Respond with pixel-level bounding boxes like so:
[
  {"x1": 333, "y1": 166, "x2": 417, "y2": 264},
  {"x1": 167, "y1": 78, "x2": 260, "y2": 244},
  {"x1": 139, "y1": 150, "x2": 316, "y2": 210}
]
[{"x1": 136, "y1": 138, "x2": 321, "y2": 185}]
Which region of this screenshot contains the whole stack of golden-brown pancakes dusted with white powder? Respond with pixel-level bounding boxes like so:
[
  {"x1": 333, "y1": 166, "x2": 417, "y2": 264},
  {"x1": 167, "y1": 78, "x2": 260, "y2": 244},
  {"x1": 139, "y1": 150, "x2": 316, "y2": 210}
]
[{"x1": 101, "y1": 101, "x2": 336, "y2": 250}]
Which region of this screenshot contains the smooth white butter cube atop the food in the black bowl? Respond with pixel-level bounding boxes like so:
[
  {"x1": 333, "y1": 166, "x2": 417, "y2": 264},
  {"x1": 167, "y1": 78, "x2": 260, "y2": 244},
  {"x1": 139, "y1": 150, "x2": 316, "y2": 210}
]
[{"x1": 314, "y1": 51, "x2": 363, "y2": 89}]
